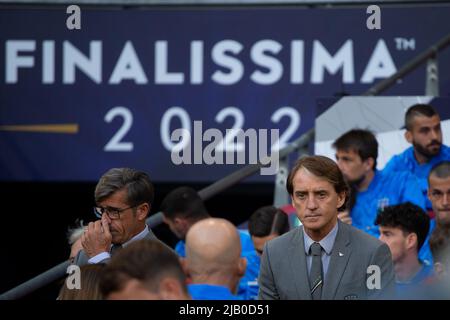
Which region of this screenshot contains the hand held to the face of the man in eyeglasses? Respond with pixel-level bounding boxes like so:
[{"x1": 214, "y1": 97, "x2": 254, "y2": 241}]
[{"x1": 81, "y1": 218, "x2": 112, "y2": 258}]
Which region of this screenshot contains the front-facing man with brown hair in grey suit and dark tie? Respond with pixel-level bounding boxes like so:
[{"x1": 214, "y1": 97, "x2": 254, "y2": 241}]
[{"x1": 259, "y1": 156, "x2": 394, "y2": 300}]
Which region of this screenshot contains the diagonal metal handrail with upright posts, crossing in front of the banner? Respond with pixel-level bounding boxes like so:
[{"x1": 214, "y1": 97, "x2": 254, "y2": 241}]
[{"x1": 0, "y1": 30, "x2": 450, "y2": 300}]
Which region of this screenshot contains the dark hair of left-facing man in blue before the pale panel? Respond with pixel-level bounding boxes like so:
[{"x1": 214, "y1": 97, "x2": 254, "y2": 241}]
[{"x1": 333, "y1": 129, "x2": 378, "y2": 170}]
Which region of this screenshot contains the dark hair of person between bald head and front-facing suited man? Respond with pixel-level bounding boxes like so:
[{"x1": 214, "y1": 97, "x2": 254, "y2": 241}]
[{"x1": 248, "y1": 206, "x2": 289, "y2": 237}]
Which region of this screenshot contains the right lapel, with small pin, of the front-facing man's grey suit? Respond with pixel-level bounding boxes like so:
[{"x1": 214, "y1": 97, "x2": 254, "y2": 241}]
[{"x1": 322, "y1": 220, "x2": 351, "y2": 300}]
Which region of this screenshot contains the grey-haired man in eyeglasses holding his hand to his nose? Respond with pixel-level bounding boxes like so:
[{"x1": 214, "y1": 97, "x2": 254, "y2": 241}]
[{"x1": 75, "y1": 168, "x2": 163, "y2": 265}]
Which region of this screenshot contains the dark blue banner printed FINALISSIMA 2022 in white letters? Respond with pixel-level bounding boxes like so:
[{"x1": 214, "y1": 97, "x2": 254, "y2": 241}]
[{"x1": 0, "y1": 6, "x2": 450, "y2": 182}]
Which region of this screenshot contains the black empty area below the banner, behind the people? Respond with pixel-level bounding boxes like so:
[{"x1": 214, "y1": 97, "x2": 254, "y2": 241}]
[{"x1": 0, "y1": 182, "x2": 274, "y2": 299}]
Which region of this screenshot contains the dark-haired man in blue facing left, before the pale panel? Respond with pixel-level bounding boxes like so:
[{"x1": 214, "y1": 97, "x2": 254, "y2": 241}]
[{"x1": 333, "y1": 129, "x2": 431, "y2": 256}]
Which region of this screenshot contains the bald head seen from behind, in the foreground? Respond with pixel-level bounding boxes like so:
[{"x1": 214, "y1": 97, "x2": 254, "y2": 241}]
[{"x1": 186, "y1": 218, "x2": 241, "y2": 274}]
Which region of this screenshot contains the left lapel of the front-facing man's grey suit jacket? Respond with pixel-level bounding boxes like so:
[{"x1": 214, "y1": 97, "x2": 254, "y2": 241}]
[{"x1": 287, "y1": 227, "x2": 311, "y2": 300}]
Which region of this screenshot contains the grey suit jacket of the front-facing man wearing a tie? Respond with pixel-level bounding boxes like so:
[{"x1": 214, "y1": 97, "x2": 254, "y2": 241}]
[{"x1": 259, "y1": 221, "x2": 395, "y2": 300}]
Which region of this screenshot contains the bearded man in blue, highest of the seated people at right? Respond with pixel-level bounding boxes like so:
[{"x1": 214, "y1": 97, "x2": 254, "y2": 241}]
[{"x1": 383, "y1": 104, "x2": 450, "y2": 210}]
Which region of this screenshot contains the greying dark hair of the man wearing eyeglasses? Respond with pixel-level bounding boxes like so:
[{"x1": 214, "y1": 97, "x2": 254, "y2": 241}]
[{"x1": 95, "y1": 168, "x2": 155, "y2": 206}]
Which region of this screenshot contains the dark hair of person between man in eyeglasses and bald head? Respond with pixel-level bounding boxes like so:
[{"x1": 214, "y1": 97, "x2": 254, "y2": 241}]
[{"x1": 161, "y1": 187, "x2": 209, "y2": 219}]
